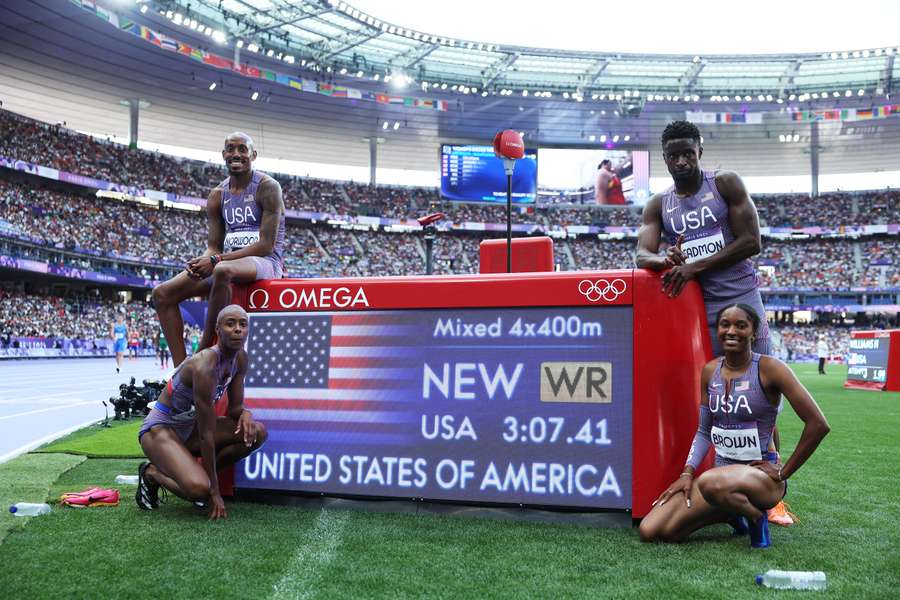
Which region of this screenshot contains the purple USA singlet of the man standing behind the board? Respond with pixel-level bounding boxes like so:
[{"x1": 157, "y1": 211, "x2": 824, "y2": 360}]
[{"x1": 660, "y1": 171, "x2": 765, "y2": 300}]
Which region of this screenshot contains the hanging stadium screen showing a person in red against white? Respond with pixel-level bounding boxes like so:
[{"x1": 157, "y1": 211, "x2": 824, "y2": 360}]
[{"x1": 538, "y1": 148, "x2": 650, "y2": 206}]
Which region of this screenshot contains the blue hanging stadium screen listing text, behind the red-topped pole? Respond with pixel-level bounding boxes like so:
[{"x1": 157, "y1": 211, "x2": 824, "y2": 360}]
[{"x1": 441, "y1": 144, "x2": 537, "y2": 204}]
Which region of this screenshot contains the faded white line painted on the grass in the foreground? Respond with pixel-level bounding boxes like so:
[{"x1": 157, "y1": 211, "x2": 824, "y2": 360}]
[{"x1": 269, "y1": 510, "x2": 350, "y2": 600}]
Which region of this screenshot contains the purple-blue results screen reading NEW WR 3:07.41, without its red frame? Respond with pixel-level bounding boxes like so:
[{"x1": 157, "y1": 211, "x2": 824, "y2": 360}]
[{"x1": 236, "y1": 306, "x2": 633, "y2": 509}]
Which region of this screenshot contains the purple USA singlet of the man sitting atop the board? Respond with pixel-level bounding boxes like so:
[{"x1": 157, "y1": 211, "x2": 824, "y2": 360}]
[{"x1": 219, "y1": 171, "x2": 284, "y2": 270}]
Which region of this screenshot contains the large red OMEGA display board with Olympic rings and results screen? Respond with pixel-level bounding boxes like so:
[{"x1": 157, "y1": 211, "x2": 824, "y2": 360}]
[{"x1": 234, "y1": 270, "x2": 710, "y2": 517}]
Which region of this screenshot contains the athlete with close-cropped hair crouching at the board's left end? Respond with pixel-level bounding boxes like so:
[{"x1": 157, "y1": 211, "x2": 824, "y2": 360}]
[{"x1": 135, "y1": 304, "x2": 267, "y2": 520}]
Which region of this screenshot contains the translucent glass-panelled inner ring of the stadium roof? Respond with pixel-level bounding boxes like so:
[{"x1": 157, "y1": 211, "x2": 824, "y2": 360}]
[{"x1": 146, "y1": 0, "x2": 900, "y2": 103}]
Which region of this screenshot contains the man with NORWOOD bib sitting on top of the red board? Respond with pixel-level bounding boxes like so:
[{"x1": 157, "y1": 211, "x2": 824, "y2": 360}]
[{"x1": 153, "y1": 132, "x2": 284, "y2": 367}]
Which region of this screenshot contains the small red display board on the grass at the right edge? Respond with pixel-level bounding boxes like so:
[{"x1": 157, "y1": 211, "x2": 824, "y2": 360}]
[{"x1": 844, "y1": 329, "x2": 900, "y2": 392}]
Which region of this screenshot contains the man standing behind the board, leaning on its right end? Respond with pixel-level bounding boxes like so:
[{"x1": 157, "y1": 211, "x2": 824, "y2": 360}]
[{"x1": 635, "y1": 121, "x2": 793, "y2": 525}]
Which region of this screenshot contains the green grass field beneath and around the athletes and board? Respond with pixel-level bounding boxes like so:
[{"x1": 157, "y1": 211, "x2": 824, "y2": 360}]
[{"x1": 0, "y1": 365, "x2": 900, "y2": 599}]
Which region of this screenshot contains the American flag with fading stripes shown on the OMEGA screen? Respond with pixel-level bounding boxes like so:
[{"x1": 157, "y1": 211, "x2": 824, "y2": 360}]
[{"x1": 244, "y1": 312, "x2": 421, "y2": 445}]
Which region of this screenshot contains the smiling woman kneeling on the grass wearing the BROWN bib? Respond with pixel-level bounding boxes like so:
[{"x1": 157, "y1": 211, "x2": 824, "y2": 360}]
[{"x1": 640, "y1": 304, "x2": 829, "y2": 548}]
